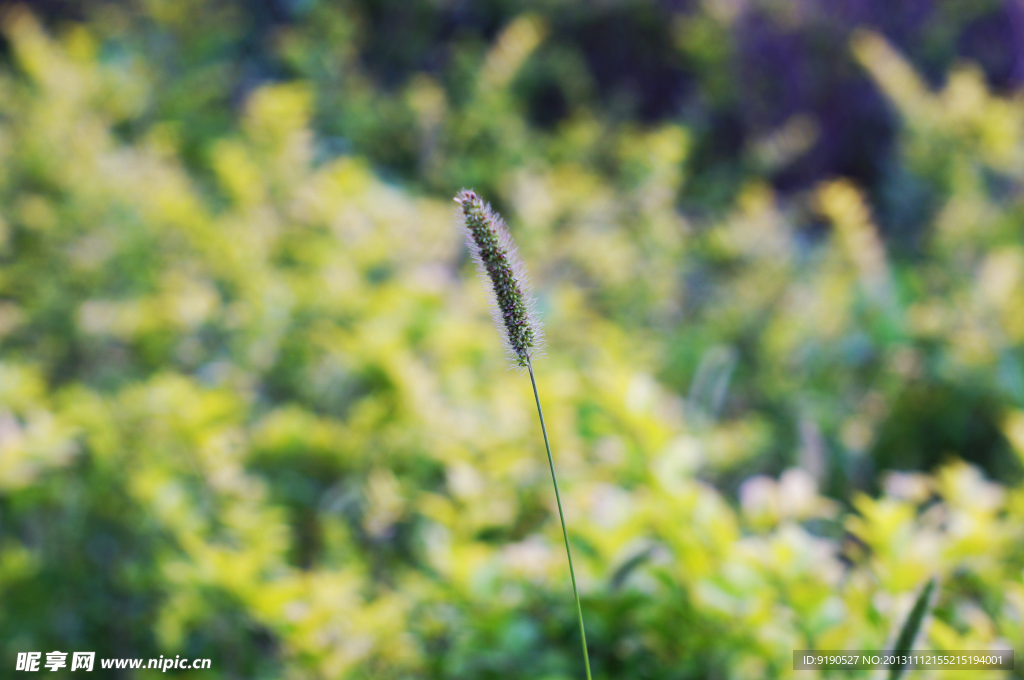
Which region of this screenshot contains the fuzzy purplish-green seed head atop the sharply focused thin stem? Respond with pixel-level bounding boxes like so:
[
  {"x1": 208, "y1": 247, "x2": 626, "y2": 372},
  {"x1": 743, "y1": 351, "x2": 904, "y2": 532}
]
[{"x1": 455, "y1": 188, "x2": 542, "y2": 367}]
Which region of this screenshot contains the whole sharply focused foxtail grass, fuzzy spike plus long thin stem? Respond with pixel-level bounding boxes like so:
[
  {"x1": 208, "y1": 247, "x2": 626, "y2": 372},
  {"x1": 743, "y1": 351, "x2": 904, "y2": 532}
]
[{"x1": 455, "y1": 188, "x2": 591, "y2": 680}]
